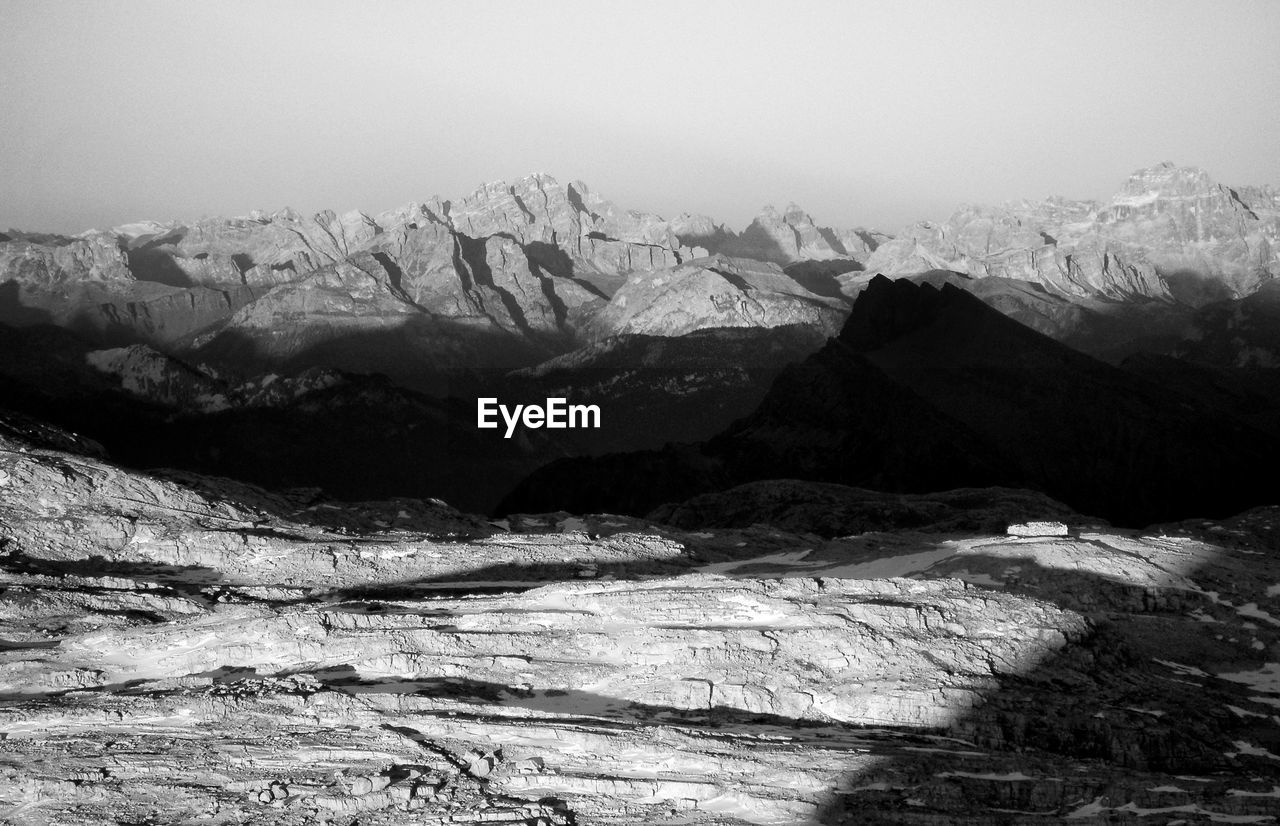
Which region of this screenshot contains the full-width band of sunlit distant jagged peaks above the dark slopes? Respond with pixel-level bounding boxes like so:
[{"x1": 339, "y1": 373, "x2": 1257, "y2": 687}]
[{"x1": 0, "y1": 164, "x2": 1280, "y2": 387}]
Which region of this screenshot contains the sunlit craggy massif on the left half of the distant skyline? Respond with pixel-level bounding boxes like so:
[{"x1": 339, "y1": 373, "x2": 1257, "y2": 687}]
[{"x1": 0, "y1": 175, "x2": 716, "y2": 365}]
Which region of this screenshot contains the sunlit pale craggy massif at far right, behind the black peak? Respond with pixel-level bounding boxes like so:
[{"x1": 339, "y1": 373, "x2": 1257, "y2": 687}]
[{"x1": 867, "y1": 164, "x2": 1280, "y2": 305}]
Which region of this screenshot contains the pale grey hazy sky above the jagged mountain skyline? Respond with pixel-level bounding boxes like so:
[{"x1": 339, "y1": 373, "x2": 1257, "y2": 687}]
[{"x1": 0, "y1": 0, "x2": 1280, "y2": 232}]
